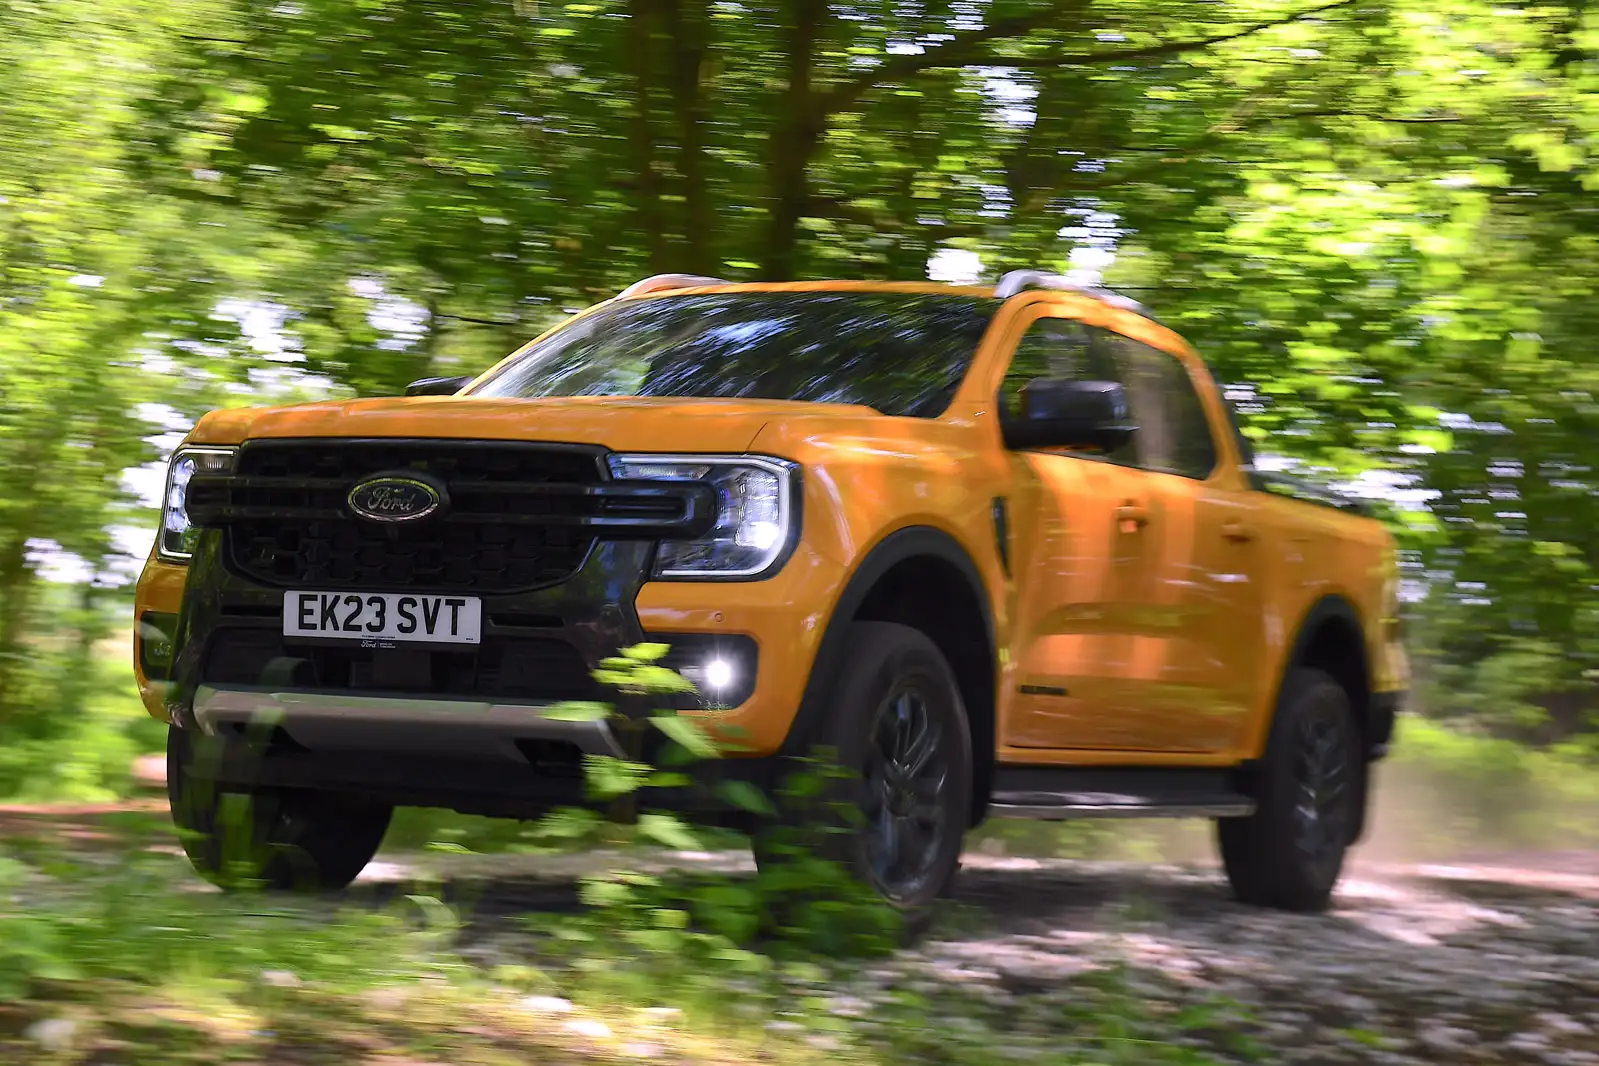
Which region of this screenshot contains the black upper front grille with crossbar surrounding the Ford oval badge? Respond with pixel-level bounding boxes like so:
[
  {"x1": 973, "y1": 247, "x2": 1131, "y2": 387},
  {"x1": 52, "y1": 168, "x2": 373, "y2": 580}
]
[{"x1": 189, "y1": 440, "x2": 715, "y2": 593}]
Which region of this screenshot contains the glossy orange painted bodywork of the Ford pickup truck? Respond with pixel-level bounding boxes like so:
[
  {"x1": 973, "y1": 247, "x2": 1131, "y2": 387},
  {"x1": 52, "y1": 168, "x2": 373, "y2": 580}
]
[{"x1": 138, "y1": 281, "x2": 1407, "y2": 766}]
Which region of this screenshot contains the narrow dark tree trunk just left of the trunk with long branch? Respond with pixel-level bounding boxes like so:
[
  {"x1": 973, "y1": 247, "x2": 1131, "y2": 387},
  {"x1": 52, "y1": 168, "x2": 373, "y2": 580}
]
[{"x1": 665, "y1": 0, "x2": 720, "y2": 273}]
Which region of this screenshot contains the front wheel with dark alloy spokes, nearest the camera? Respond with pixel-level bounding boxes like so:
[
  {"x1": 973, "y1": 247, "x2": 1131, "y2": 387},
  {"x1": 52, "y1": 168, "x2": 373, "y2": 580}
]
[{"x1": 755, "y1": 622, "x2": 972, "y2": 925}]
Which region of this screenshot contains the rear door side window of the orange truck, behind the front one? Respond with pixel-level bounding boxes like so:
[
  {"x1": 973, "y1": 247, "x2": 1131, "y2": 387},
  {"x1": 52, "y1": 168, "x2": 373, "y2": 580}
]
[{"x1": 1107, "y1": 334, "x2": 1215, "y2": 479}]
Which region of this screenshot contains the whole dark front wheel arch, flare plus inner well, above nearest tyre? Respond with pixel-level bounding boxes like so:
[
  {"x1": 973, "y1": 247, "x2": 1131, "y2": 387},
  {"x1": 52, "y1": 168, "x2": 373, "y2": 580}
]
[{"x1": 779, "y1": 526, "x2": 996, "y2": 825}]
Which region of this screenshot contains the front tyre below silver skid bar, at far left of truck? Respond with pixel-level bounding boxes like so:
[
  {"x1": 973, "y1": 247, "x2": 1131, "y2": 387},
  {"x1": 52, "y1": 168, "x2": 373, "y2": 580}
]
[{"x1": 166, "y1": 727, "x2": 393, "y2": 892}]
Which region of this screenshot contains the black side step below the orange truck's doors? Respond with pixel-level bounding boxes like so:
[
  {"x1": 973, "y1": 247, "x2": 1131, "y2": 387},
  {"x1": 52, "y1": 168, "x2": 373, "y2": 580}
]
[{"x1": 988, "y1": 766, "x2": 1255, "y2": 820}]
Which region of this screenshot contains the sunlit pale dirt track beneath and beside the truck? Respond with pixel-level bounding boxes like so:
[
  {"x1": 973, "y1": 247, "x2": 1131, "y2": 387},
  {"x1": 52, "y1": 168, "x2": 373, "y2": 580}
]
[{"x1": 12, "y1": 804, "x2": 1599, "y2": 1066}]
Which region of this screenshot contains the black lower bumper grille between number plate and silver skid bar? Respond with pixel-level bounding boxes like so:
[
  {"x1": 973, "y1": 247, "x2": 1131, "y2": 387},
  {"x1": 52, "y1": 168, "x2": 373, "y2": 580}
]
[{"x1": 200, "y1": 626, "x2": 603, "y2": 702}]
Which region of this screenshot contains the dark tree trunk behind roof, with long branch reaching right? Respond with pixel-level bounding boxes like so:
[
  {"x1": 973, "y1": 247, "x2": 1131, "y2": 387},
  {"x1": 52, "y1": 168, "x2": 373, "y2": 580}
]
[{"x1": 761, "y1": 0, "x2": 827, "y2": 281}]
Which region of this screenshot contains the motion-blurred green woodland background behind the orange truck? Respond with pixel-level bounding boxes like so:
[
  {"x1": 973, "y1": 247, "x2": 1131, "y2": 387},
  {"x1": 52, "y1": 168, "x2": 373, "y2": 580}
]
[{"x1": 0, "y1": 0, "x2": 1599, "y2": 1061}]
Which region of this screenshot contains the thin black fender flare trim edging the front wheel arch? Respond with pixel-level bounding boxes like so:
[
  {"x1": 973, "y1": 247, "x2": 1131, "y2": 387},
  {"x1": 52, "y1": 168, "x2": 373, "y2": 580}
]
[{"x1": 777, "y1": 526, "x2": 995, "y2": 759}]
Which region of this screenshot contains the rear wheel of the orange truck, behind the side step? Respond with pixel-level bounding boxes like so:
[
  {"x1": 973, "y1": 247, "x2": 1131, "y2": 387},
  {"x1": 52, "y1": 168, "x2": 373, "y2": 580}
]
[{"x1": 1217, "y1": 670, "x2": 1366, "y2": 911}]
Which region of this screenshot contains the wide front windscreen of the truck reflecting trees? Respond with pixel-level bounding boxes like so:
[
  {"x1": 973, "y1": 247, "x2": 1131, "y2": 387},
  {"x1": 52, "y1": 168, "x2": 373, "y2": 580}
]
[{"x1": 472, "y1": 292, "x2": 998, "y2": 419}]
